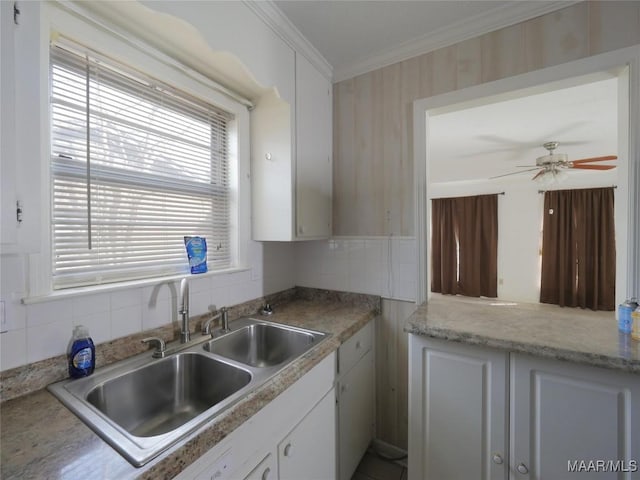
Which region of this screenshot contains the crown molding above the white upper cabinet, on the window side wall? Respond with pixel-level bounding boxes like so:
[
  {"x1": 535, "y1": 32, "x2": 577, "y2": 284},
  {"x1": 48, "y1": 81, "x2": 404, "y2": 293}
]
[{"x1": 244, "y1": 0, "x2": 333, "y2": 81}]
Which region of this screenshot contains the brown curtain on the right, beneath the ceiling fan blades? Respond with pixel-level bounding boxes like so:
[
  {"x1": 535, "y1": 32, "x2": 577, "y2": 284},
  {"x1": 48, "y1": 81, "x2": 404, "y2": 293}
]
[{"x1": 540, "y1": 187, "x2": 616, "y2": 310}]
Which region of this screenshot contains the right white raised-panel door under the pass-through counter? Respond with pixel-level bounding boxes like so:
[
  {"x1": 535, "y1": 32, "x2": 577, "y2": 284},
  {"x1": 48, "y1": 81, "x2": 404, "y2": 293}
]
[{"x1": 510, "y1": 354, "x2": 640, "y2": 480}]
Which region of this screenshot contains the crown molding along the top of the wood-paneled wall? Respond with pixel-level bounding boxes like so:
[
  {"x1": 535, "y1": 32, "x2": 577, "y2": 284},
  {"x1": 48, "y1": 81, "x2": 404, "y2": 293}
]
[{"x1": 333, "y1": 1, "x2": 579, "y2": 83}]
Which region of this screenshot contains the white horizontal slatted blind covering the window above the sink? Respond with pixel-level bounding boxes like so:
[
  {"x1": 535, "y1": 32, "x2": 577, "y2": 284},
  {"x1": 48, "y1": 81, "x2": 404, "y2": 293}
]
[{"x1": 50, "y1": 42, "x2": 233, "y2": 289}]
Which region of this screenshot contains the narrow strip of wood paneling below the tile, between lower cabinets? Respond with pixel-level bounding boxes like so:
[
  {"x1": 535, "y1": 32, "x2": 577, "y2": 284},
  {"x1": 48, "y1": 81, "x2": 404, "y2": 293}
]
[{"x1": 376, "y1": 299, "x2": 416, "y2": 450}]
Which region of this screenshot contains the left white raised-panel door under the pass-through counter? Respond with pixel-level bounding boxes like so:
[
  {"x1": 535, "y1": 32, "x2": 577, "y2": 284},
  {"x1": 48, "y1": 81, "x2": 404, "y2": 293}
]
[{"x1": 409, "y1": 335, "x2": 508, "y2": 480}]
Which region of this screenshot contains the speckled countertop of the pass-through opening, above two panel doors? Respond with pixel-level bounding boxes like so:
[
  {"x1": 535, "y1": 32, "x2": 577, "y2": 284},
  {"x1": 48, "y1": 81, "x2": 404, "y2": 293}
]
[{"x1": 405, "y1": 295, "x2": 640, "y2": 374}]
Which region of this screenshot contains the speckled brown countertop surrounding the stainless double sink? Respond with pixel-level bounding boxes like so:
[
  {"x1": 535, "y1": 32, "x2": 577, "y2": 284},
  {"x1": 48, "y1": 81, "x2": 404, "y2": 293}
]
[{"x1": 0, "y1": 298, "x2": 379, "y2": 480}]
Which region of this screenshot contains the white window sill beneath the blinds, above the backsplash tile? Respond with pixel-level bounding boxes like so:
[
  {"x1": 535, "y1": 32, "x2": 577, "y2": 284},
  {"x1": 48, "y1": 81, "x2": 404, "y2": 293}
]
[{"x1": 21, "y1": 267, "x2": 251, "y2": 305}]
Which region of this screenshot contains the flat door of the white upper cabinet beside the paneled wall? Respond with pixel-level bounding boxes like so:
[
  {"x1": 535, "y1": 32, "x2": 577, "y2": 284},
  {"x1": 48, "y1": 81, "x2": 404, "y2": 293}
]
[{"x1": 296, "y1": 55, "x2": 332, "y2": 238}]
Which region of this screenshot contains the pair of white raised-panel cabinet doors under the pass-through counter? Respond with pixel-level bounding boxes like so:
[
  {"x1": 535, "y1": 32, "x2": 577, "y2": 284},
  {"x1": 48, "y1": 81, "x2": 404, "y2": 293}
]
[{"x1": 409, "y1": 335, "x2": 640, "y2": 480}]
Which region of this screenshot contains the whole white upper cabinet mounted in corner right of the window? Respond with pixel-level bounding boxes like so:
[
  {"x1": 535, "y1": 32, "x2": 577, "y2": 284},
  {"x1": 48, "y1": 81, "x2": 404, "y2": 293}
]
[{"x1": 251, "y1": 54, "x2": 332, "y2": 241}]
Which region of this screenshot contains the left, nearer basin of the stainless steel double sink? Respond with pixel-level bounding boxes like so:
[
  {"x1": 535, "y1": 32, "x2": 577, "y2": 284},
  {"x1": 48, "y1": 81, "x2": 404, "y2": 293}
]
[{"x1": 86, "y1": 353, "x2": 251, "y2": 437}]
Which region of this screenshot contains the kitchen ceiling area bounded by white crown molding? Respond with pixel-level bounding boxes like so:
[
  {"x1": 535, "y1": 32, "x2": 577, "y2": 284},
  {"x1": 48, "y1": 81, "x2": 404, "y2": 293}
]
[{"x1": 274, "y1": 0, "x2": 575, "y2": 81}]
